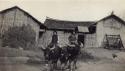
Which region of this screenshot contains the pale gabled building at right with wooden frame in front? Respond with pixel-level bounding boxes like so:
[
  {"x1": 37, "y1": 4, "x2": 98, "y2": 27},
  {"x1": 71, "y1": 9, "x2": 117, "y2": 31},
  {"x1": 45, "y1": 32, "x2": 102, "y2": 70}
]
[{"x1": 96, "y1": 13, "x2": 125, "y2": 48}]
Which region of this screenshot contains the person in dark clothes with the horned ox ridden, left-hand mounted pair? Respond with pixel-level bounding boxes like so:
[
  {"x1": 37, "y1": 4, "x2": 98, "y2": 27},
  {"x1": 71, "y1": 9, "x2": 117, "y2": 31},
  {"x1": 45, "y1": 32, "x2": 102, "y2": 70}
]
[{"x1": 41, "y1": 31, "x2": 61, "y2": 70}]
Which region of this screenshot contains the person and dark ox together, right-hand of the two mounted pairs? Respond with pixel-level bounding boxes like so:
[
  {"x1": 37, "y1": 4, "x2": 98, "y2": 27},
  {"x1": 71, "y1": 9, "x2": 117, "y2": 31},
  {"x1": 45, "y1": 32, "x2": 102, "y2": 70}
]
[{"x1": 67, "y1": 32, "x2": 80, "y2": 68}]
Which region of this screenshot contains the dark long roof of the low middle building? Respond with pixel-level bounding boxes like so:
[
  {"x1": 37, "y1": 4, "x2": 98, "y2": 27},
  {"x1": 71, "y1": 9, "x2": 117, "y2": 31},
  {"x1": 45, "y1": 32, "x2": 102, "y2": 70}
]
[{"x1": 44, "y1": 18, "x2": 95, "y2": 30}]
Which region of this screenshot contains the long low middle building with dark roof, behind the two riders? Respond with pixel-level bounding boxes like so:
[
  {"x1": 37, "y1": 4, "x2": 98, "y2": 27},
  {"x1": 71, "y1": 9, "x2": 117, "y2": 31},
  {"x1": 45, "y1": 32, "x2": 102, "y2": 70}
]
[{"x1": 40, "y1": 17, "x2": 96, "y2": 47}]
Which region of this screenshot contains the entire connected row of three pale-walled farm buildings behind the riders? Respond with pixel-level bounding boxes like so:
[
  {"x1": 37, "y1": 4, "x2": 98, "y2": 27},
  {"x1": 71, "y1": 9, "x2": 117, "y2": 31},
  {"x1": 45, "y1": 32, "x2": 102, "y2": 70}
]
[{"x1": 0, "y1": 6, "x2": 125, "y2": 48}]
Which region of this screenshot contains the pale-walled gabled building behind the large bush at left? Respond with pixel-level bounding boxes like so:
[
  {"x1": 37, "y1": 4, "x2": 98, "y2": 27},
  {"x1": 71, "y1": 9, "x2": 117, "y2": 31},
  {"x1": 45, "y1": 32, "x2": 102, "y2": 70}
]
[{"x1": 0, "y1": 6, "x2": 45, "y2": 42}]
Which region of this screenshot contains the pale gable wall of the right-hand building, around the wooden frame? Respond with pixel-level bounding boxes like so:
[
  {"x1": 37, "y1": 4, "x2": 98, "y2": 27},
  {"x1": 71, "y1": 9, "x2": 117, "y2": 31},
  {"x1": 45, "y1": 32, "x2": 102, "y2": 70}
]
[{"x1": 97, "y1": 18, "x2": 125, "y2": 47}]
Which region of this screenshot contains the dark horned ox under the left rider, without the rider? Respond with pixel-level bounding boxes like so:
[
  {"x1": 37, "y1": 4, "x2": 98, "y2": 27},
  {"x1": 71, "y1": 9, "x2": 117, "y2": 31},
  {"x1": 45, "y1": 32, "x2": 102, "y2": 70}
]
[{"x1": 41, "y1": 45, "x2": 61, "y2": 68}]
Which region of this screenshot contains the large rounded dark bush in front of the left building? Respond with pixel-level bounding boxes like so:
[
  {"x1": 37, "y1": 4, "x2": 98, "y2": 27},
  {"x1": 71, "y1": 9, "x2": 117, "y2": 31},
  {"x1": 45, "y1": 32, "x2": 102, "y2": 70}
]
[{"x1": 2, "y1": 25, "x2": 36, "y2": 49}]
